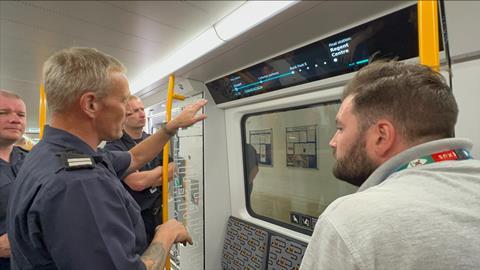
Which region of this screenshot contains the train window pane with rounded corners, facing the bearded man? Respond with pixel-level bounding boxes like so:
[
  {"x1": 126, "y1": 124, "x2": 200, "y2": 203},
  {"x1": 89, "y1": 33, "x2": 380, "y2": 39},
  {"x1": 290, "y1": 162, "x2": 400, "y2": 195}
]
[{"x1": 242, "y1": 101, "x2": 357, "y2": 234}]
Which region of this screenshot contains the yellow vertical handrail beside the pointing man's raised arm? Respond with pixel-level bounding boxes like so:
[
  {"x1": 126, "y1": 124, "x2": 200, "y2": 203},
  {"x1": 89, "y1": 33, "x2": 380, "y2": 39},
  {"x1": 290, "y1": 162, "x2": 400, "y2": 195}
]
[{"x1": 162, "y1": 74, "x2": 185, "y2": 270}]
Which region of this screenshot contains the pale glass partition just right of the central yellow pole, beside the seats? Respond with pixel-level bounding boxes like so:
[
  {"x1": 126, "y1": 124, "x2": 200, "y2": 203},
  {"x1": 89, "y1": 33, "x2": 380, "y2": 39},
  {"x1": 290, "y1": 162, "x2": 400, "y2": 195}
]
[{"x1": 148, "y1": 94, "x2": 205, "y2": 270}]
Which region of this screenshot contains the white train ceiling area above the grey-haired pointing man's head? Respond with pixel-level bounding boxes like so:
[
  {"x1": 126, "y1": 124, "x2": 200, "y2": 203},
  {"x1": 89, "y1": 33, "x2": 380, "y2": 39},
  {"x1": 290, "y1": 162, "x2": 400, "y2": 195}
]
[{"x1": 0, "y1": 1, "x2": 245, "y2": 131}]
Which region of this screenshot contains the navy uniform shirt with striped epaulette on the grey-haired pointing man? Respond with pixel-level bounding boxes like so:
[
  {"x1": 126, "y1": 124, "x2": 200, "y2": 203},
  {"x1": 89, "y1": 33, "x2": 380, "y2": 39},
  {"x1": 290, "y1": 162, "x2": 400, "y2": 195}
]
[{"x1": 7, "y1": 126, "x2": 147, "y2": 270}]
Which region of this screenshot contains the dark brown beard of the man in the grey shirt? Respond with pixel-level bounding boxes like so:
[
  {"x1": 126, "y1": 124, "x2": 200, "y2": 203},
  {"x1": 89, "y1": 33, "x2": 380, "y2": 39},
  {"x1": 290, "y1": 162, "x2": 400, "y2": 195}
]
[{"x1": 333, "y1": 136, "x2": 378, "y2": 187}]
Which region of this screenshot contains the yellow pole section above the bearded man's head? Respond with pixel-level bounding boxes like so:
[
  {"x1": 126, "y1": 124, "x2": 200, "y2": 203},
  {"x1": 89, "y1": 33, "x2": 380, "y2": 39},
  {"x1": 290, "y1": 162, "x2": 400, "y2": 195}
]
[{"x1": 418, "y1": 0, "x2": 440, "y2": 71}]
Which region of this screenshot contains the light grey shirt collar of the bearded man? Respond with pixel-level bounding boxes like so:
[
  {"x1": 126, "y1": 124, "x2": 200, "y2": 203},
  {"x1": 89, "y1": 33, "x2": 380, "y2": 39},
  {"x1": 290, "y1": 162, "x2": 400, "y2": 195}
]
[{"x1": 357, "y1": 138, "x2": 473, "y2": 192}]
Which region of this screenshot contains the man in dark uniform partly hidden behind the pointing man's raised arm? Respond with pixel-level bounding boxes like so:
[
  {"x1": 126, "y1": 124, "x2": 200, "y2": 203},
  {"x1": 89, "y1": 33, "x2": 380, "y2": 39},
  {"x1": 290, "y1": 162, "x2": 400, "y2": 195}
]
[{"x1": 104, "y1": 95, "x2": 175, "y2": 242}]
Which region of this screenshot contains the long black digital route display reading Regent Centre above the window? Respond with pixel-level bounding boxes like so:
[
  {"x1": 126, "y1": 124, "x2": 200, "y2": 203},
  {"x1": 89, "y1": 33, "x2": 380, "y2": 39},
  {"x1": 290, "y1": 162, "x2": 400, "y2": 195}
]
[{"x1": 206, "y1": 5, "x2": 418, "y2": 104}]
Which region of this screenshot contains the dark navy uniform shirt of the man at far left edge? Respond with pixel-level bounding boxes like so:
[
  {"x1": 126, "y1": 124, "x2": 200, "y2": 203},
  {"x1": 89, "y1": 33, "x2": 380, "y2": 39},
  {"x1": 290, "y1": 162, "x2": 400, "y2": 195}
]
[{"x1": 0, "y1": 146, "x2": 28, "y2": 270}]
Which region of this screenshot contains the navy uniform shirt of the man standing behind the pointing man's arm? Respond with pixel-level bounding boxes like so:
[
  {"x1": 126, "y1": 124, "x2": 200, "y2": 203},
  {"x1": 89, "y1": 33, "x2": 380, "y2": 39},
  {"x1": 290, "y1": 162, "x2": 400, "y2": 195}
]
[{"x1": 104, "y1": 131, "x2": 172, "y2": 242}]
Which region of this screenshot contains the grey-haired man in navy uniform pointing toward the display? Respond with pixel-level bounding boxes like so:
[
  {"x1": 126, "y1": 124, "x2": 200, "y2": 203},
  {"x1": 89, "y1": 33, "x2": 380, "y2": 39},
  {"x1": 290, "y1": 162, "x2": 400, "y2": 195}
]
[{"x1": 7, "y1": 47, "x2": 206, "y2": 270}]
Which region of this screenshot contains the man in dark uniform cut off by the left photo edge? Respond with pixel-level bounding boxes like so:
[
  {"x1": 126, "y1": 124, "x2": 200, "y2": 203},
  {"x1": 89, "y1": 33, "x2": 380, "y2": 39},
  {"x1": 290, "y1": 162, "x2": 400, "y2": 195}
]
[{"x1": 0, "y1": 89, "x2": 27, "y2": 270}]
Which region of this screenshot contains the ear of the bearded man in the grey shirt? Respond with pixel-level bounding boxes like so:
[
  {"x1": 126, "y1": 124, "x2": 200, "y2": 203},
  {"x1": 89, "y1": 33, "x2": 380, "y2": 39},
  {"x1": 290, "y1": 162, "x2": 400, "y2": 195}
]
[{"x1": 371, "y1": 119, "x2": 398, "y2": 158}]
